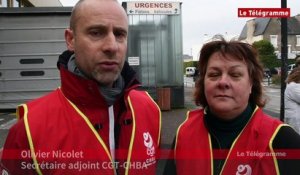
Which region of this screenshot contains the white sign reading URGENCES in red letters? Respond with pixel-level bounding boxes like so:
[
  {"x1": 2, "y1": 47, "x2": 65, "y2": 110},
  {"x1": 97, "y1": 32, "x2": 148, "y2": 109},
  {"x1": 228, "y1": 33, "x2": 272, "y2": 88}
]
[{"x1": 127, "y1": 1, "x2": 180, "y2": 15}]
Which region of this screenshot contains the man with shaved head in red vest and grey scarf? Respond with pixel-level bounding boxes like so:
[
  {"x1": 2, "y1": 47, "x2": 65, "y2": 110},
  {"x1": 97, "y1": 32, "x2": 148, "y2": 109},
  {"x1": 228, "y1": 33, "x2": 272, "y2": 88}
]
[{"x1": 0, "y1": 0, "x2": 161, "y2": 174}]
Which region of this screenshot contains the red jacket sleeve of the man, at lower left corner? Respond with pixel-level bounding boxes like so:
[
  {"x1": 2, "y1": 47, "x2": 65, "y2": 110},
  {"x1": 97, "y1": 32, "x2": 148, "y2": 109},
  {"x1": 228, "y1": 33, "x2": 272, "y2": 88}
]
[{"x1": 0, "y1": 119, "x2": 35, "y2": 175}]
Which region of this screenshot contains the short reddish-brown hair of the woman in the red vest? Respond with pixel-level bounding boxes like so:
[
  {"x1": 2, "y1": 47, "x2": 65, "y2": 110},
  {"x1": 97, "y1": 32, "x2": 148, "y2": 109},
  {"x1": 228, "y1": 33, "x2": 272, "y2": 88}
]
[{"x1": 194, "y1": 39, "x2": 266, "y2": 107}]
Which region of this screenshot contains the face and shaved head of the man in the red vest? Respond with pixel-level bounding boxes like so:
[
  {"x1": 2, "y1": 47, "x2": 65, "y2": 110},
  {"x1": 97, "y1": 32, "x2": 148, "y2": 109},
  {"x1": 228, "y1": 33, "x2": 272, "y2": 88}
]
[{"x1": 65, "y1": 0, "x2": 128, "y2": 87}]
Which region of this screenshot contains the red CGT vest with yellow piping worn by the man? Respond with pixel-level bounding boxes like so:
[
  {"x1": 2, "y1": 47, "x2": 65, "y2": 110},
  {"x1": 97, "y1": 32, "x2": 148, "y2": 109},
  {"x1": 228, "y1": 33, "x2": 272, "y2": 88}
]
[{"x1": 17, "y1": 89, "x2": 161, "y2": 175}]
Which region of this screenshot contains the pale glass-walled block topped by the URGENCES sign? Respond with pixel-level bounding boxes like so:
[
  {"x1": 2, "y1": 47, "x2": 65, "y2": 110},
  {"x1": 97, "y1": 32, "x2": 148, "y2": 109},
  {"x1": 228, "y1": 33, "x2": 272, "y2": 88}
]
[{"x1": 122, "y1": 1, "x2": 184, "y2": 107}]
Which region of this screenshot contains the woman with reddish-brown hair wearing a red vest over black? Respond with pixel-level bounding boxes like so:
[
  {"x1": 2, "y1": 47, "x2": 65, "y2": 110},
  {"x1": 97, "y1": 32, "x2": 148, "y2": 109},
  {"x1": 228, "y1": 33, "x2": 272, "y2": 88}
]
[{"x1": 165, "y1": 40, "x2": 300, "y2": 175}]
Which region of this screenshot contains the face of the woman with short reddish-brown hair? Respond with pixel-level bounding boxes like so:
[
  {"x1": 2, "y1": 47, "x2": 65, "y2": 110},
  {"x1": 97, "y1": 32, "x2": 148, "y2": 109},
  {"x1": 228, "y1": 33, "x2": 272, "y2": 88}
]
[{"x1": 204, "y1": 52, "x2": 252, "y2": 119}]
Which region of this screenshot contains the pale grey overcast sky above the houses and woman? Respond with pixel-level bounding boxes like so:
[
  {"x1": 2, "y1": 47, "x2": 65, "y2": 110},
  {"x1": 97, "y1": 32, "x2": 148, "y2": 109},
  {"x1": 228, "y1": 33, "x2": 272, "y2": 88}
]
[{"x1": 60, "y1": 0, "x2": 300, "y2": 54}]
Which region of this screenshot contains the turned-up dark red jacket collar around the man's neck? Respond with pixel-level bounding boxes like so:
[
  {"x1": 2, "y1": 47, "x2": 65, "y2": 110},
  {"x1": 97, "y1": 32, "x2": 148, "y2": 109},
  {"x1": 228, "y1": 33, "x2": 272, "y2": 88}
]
[{"x1": 57, "y1": 50, "x2": 140, "y2": 107}]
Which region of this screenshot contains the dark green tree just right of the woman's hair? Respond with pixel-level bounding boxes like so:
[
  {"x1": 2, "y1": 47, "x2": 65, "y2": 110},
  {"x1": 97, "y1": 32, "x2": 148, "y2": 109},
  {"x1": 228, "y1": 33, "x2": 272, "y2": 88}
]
[{"x1": 253, "y1": 40, "x2": 281, "y2": 69}]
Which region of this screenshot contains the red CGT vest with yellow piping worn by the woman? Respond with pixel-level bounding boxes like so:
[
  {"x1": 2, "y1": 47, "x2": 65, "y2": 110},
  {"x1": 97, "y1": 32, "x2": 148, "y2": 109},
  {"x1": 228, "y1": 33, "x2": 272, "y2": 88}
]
[{"x1": 174, "y1": 108, "x2": 284, "y2": 175}]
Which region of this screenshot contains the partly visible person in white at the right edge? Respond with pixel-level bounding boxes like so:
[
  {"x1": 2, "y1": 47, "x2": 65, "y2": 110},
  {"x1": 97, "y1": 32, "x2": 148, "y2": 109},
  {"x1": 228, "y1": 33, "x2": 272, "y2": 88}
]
[{"x1": 284, "y1": 67, "x2": 300, "y2": 133}]
